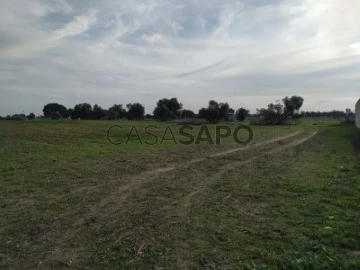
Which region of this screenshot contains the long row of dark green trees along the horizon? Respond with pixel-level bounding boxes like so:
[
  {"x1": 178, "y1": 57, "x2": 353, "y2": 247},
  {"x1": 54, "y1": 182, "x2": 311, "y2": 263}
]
[{"x1": 0, "y1": 96, "x2": 352, "y2": 125}]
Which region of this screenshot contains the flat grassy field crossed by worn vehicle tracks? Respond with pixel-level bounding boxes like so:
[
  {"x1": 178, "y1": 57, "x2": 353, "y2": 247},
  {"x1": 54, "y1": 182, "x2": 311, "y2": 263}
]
[{"x1": 0, "y1": 120, "x2": 360, "y2": 270}]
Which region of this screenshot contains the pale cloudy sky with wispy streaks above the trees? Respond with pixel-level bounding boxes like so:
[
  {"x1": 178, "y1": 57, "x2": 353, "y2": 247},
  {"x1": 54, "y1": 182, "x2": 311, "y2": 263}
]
[{"x1": 0, "y1": 0, "x2": 360, "y2": 115}]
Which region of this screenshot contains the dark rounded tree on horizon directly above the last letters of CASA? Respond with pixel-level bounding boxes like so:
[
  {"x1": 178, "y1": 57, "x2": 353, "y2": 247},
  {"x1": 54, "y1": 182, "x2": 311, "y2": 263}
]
[{"x1": 153, "y1": 98, "x2": 182, "y2": 121}]
